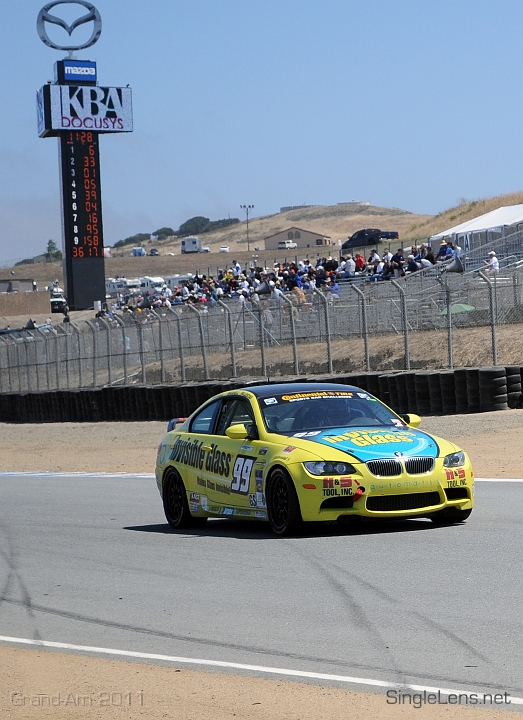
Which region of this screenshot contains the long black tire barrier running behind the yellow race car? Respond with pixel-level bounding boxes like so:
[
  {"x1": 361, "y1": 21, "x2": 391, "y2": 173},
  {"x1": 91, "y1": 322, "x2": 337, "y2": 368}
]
[{"x1": 0, "y1": 365, "x2": 523, "y2": 423}]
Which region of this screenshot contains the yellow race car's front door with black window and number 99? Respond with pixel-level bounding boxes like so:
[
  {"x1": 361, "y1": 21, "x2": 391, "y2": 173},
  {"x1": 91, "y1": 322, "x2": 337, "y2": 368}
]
[{"x1": 205, "y1": 397, "x2": 260, "y2": 516}]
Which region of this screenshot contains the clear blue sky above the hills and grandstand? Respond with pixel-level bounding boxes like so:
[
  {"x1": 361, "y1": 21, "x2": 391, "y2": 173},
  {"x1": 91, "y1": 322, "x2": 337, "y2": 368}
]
[{"x1": 0, "y1": 0, "x2": 523, "y2": 262}]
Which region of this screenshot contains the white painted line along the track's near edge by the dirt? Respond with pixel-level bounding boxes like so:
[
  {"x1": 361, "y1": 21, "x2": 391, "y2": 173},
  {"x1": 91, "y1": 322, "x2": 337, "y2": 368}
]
[{"x1": 0, "y1": 635, "x2": 523, "y2": 705}]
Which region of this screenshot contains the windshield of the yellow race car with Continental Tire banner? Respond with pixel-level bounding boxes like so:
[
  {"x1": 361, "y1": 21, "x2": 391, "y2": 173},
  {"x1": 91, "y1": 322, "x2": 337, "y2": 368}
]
[{"x1": 258, "y1": 390, "x2": 405, "y2": 437}]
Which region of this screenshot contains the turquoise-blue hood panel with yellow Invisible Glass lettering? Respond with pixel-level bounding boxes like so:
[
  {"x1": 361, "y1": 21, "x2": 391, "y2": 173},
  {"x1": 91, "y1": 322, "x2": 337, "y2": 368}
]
[{"x1": 295, "y1": 427, "x2": 439, "y2": 462}]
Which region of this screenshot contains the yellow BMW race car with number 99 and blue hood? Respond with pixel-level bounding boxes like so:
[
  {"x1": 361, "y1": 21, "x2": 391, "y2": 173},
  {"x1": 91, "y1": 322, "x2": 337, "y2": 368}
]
[{"x1": 156, "y1": 383, "x2": 474, "y2": 535}]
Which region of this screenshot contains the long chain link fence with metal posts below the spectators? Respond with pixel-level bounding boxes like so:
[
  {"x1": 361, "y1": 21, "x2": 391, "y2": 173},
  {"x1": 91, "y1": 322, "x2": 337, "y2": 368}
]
[{"x1": 0, "y1": 267, "x2": 523, "y2": 393}]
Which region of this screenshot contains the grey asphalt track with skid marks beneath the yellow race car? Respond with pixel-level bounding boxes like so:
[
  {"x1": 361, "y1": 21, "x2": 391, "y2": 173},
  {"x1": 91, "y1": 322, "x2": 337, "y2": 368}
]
[{"x1": 0, "y1": 473, "x2": 523, "y2": 697}]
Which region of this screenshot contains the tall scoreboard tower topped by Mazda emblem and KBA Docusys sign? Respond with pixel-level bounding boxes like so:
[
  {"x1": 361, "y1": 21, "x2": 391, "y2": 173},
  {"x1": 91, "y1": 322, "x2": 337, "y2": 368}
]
[{"x1": 37, "y1": 0, "x2": 133, "y2": 310}]
